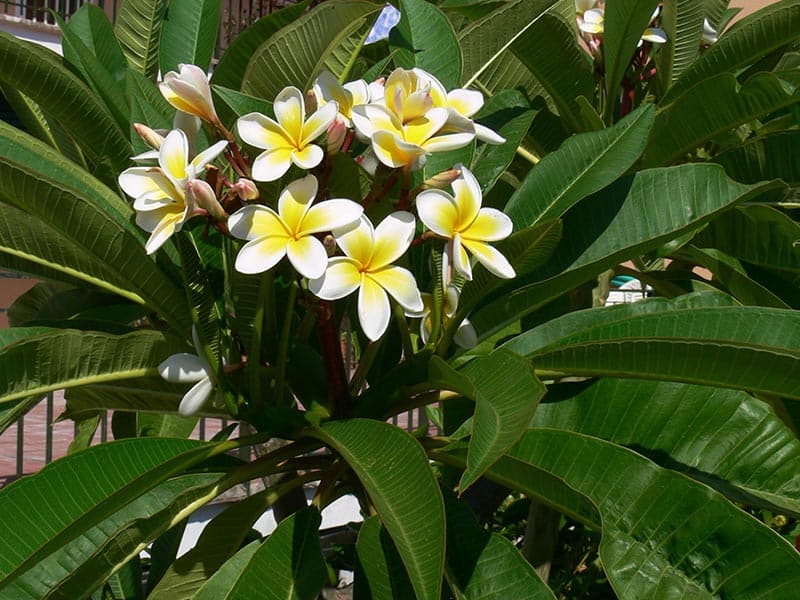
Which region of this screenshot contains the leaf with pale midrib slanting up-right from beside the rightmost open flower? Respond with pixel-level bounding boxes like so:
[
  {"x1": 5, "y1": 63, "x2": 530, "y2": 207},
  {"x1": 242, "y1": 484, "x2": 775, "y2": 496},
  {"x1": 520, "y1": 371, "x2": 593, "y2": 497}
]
[{"x1": 505, "y1": 105, "x2": 654, "y2": 229}]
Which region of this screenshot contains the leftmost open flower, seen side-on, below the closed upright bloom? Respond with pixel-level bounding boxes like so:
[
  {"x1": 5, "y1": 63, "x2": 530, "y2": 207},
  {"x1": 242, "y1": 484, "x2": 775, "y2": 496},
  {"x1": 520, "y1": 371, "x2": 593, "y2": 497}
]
[{"x1": 118, "y1": 129, "x2": 227, "y2": 254}]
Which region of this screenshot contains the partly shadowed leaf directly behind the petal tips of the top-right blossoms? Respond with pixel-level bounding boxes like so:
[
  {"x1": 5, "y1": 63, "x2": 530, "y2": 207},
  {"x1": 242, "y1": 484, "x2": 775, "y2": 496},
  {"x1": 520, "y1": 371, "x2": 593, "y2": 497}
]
[{"x1": 470, "y1": 90, "x2": 534, "y2": 193}]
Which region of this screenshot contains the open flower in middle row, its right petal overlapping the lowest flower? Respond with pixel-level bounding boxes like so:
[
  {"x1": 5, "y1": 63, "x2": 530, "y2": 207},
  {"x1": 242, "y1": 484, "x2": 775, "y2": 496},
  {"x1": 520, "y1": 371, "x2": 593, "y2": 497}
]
[{"x1": 228, "y1": 175, "x2": 364, "y2": 279}]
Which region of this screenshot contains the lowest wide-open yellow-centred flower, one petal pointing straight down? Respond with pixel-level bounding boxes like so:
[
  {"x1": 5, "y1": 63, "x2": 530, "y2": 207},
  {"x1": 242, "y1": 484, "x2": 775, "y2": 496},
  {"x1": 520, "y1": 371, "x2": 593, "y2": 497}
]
[{"x1": 308, "y1": 211, "x2": 423, "y2": 341}]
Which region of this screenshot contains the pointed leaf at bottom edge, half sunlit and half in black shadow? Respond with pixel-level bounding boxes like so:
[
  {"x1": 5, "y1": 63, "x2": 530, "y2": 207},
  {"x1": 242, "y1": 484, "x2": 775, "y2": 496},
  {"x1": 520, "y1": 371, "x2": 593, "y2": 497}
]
[{"x1": 194, "y1": 507, "x2": 327, "y2": 600}]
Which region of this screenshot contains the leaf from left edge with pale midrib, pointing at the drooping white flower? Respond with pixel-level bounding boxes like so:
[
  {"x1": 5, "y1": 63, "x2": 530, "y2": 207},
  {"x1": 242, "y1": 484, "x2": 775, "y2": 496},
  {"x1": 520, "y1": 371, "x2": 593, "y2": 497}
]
[{"x1": 0, "y1": 327, "x2": 184, "y2": 403}]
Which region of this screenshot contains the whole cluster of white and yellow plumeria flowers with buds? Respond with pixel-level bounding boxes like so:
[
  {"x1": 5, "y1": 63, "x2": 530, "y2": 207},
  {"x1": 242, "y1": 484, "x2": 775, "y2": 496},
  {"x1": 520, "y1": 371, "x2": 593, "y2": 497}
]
[{"x1": 119, "y1": 65, "x2": 515, "y2": 412}]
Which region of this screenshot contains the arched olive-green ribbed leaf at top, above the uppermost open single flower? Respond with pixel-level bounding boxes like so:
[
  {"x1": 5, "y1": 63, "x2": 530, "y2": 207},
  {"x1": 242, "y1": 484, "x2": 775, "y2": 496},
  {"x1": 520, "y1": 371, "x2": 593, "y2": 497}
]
[{"x1": 241, "y1": 0, "x2": 380, "y2": 101}]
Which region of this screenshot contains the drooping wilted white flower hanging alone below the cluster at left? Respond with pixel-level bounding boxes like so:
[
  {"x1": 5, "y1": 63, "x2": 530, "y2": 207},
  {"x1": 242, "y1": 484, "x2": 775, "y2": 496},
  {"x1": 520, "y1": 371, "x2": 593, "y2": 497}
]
[{"x1": 158, "y1": 328, "x2": 219, "y2": 417}]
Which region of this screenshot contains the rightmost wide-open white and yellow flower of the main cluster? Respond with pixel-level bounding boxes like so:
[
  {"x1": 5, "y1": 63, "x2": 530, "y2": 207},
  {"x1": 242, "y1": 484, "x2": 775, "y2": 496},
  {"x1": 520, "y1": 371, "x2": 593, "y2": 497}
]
[{"x1": 416, "y1": 165, "x2": 516, "y2": 279}]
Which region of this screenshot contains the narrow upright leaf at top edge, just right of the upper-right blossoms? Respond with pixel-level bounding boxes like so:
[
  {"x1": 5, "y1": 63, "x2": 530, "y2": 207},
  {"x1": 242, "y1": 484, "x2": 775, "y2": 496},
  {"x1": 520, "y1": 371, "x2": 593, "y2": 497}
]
[{"x1": 655, "y1": 0, "x2": 704, "y2": 91}]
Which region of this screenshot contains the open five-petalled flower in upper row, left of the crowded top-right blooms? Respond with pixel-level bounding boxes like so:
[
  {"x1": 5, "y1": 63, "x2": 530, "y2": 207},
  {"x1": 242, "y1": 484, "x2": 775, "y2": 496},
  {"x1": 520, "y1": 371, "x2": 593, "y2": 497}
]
[{"x1": 236, "y1": 87, "x2": 339, "y2": 181}]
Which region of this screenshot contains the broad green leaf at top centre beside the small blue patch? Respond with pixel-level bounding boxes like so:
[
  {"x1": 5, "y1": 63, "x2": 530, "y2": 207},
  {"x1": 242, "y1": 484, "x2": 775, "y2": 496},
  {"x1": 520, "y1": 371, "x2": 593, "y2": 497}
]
[{"x1": 389, "y1": 0, "x2": 461, "y2": 90}]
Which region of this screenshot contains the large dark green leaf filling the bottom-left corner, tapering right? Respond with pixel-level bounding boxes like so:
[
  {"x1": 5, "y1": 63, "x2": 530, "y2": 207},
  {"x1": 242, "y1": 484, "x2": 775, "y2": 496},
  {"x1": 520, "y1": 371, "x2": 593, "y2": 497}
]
[{"x1": 0, "y1": 438, "x2": 235, "y2": 597}]
